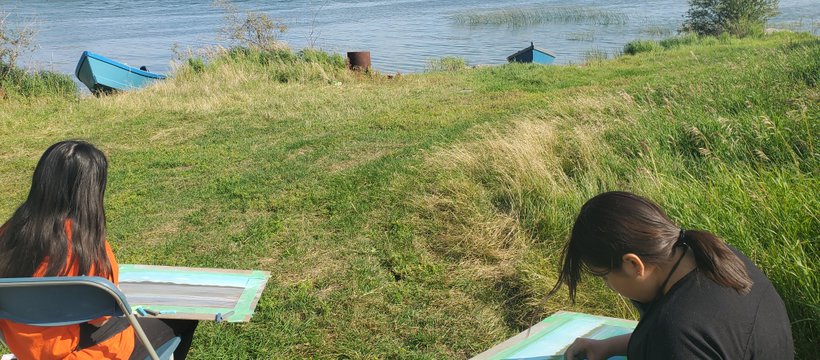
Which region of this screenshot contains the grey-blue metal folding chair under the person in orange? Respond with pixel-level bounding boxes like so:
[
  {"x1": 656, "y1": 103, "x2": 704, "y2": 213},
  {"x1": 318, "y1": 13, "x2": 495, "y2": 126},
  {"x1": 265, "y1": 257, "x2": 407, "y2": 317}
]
[{"x1": 0, "y1": 276, "x2": 180, "y2": 360}]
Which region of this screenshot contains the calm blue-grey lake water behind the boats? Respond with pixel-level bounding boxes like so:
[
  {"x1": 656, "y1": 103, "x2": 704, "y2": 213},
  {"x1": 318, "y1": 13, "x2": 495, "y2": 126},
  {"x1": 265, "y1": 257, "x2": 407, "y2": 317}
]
[{"x1": 0, "y1": 0, "x2": 820, "y2": 73}]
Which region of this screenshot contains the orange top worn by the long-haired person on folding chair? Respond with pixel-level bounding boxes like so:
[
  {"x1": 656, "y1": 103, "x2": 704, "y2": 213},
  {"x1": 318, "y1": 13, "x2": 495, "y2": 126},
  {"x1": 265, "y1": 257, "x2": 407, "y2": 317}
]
[{"x1": 0, "y1": 220, "x2": 134, "y2": 360}]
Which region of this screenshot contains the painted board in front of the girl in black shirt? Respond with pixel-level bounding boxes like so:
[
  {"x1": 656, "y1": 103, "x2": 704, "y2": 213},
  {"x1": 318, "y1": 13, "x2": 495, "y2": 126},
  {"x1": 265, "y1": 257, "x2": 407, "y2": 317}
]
[{"x1": 473, "y1": 311, "x2": 638, "y2": 360}]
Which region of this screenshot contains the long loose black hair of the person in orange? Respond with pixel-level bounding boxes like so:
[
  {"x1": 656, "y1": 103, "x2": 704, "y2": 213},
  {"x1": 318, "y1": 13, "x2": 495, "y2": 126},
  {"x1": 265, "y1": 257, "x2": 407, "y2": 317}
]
[{"x1": 0, "y1": 140, "x2": 111, "y2": 277}]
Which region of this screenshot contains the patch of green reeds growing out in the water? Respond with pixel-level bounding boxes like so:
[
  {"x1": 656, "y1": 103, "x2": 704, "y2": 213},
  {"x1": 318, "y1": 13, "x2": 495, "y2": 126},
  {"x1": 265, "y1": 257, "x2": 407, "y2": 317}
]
[{"x1": 452, "y1": 6, "x2": 629, "y2": 27}]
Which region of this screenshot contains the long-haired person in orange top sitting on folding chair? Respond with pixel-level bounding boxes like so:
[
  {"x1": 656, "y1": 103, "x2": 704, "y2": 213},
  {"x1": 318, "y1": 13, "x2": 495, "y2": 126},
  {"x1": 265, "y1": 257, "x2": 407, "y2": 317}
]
[{"x1": 0, "y1": 141, "x2": 198, "y2": 360}]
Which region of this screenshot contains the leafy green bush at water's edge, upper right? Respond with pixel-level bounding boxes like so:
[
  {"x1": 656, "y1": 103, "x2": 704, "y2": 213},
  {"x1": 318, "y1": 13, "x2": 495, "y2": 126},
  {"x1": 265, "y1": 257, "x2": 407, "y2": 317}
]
[{"x1": 681, "y1": 0, "x2": 780, "y2": 37}]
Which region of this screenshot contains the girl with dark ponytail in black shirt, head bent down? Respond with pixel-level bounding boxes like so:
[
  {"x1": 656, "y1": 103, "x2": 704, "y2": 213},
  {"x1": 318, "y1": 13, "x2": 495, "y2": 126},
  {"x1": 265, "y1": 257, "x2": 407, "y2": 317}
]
[{"x1": 553, "y1": 192, "x2": 794, "y2": 360}]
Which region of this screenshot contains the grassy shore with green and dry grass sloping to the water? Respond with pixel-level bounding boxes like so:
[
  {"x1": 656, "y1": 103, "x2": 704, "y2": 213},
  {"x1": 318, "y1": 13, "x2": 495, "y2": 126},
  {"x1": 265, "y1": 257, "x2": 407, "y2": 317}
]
[{"x1": 0, "y1": 33, "x2": 820, "y2": 359}]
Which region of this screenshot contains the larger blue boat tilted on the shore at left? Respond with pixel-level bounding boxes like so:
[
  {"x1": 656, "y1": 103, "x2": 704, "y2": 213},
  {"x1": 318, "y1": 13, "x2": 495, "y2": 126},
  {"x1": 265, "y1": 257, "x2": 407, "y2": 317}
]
[{"x1": 74, "y1": 51, "x2": 165, "y2": 94}]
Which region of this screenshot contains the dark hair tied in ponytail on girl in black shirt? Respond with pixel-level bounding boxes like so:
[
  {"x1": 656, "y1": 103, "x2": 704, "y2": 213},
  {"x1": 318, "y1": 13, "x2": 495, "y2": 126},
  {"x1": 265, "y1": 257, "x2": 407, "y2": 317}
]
[{"x1": 551, "y1": 191, "x2": 752, "y2": 301}]
